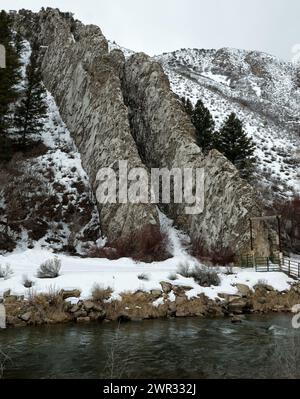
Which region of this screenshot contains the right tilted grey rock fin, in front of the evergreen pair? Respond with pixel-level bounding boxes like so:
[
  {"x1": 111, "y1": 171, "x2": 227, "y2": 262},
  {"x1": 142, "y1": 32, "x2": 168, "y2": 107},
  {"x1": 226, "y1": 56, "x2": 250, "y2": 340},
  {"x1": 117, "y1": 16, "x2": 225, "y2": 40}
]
[{"x1": 124, "y1": 54, "x2": 260, "y2": 252}]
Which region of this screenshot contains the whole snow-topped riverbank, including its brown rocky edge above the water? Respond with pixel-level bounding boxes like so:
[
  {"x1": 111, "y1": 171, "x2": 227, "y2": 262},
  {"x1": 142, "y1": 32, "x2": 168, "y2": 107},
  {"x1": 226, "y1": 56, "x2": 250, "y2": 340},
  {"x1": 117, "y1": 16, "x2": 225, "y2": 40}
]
[{"x1": 0, "y1": 249, "x2": 300, "y2": 327}]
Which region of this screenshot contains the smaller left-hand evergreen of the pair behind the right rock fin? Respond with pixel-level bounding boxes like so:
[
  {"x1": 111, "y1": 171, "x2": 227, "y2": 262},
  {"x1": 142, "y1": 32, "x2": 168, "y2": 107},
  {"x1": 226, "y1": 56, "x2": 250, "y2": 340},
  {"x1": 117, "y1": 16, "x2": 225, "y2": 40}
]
[{"x1": 192, "y1": 100, "x2": 215, "y2": 153}]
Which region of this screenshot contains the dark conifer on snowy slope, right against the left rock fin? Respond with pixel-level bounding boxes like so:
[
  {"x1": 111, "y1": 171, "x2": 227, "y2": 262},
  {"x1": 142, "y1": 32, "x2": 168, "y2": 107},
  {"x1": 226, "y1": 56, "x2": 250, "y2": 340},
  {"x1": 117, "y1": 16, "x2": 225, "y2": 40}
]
[{"x1": 15, "y1": 46, "x2": 47, "y2": 148}]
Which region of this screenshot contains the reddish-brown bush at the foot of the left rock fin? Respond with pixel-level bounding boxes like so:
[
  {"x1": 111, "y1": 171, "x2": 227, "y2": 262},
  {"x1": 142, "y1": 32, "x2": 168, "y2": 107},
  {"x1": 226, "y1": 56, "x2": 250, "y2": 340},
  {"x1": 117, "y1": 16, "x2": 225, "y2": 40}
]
[{"x1": 88, "y1": 224, "x2": 170, "y2": 263}]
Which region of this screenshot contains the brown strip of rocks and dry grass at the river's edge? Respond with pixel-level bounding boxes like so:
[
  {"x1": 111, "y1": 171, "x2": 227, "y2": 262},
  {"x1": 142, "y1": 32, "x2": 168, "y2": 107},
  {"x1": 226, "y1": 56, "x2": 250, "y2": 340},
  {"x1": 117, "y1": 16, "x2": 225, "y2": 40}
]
[{"x1": 3, "y1": 282, "x2": 300, "y2": 327}]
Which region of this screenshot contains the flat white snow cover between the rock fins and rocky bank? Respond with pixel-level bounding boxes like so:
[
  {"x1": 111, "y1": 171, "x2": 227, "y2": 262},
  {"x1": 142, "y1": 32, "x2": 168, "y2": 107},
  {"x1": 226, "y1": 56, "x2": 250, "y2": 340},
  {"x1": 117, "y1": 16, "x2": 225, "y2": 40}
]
[{"x1": 0, "y1": 249, "x2": 293, "y2": 306}]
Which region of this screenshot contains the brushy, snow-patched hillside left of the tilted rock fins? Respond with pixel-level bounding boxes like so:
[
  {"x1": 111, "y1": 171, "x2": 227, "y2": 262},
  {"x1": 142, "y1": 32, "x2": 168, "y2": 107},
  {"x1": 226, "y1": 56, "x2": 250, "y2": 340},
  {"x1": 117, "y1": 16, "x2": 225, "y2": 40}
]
[{"x1": 0, "y1": 41, "x2": 100, "y2": 253}]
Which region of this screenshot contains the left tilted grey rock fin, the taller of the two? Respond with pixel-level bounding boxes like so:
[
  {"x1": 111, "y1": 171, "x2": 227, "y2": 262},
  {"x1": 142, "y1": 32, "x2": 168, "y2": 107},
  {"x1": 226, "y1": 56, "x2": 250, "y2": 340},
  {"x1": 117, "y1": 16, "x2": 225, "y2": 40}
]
[{"x1": 16, "y1": 9, "x2": 159, "y2": 240}]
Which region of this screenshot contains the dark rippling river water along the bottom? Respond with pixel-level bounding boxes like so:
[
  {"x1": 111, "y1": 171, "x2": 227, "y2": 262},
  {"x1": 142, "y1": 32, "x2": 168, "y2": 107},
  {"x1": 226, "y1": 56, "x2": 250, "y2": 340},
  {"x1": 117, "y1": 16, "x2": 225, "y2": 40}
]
[{"x1": 0, "y1": 315, "x2": 300, "y2": 379}]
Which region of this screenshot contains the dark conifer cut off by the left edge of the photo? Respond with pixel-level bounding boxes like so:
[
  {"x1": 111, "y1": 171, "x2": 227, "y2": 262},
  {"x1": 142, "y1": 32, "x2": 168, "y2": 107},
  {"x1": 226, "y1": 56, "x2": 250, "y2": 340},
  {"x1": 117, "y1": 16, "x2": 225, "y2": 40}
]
[{"x1": 0, "y1": 11, "x2": 21, "y2": 161}]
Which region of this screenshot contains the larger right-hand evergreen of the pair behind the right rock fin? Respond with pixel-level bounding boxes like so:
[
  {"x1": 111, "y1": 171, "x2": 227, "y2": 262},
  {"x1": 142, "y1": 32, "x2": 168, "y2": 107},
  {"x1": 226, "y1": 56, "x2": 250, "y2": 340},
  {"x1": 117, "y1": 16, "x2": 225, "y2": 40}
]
[{"x1": 215, "y1": 113, "x2": 255, "y2": 177}]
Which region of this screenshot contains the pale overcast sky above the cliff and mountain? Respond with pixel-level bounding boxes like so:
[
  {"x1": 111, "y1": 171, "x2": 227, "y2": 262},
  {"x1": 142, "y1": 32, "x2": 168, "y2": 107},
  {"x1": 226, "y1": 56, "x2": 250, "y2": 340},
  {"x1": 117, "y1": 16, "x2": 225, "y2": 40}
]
[{"x1": 0, "y1": 0, "x2": 300, "y2": 60}]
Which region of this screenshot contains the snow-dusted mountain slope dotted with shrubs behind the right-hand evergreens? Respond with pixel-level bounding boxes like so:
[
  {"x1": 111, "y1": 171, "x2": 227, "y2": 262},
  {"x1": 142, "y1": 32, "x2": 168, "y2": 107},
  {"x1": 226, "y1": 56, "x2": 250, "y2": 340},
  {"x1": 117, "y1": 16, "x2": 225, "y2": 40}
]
[{"x1": 155, "y1": 48, "x2": 300, "y2": 200}]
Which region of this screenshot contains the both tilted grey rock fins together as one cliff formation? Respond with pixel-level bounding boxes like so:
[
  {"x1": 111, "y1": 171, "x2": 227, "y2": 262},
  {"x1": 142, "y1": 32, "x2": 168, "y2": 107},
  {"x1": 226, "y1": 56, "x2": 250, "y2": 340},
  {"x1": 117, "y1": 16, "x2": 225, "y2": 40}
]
[{"x1": 15, "y1": 9, "x2": 268, "y2": 252}]
